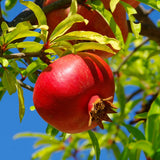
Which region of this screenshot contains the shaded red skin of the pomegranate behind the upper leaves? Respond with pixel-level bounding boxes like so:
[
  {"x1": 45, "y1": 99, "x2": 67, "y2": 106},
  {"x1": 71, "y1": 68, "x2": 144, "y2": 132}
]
[{"x1": 44, "y1": 0, "x2": 128, "y2": 58}]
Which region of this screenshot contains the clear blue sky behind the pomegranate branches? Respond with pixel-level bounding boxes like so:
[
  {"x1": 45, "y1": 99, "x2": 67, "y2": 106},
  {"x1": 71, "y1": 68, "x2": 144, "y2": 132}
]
[{"x1": 0, "y1": 0, "x2": 157, "y2": 160}]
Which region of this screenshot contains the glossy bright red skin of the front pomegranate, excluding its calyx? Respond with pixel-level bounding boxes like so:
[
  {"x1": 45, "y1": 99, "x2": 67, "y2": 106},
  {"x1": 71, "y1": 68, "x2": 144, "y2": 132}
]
[{"x1": 33, "y1": 53, "x2": 114, "y2": 133}]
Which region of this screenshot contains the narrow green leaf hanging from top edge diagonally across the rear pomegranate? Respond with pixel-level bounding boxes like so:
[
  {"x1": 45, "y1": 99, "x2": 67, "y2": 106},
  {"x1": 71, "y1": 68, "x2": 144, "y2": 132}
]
[{"x1": 89, "y1": 0, "x2": 124, "y2": 48}]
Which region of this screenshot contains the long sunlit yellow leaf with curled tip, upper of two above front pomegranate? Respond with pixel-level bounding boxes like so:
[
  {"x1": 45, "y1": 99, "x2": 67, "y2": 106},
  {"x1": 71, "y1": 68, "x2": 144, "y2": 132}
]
[{"x1": 55, "y1": 31, "x2": 121, "y2": 50}]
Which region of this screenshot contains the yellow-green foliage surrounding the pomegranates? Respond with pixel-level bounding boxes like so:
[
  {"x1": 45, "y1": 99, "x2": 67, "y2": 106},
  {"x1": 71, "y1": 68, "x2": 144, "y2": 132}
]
[{"x1": 0, "y1": 0, "x2": 160, "y2": 160}]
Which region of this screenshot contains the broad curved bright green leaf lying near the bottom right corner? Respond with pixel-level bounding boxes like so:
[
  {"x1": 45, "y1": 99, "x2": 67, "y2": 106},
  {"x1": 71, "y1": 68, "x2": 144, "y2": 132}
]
[{"x1": 128, "y1": 140, "x2": 154, "y2": 157}]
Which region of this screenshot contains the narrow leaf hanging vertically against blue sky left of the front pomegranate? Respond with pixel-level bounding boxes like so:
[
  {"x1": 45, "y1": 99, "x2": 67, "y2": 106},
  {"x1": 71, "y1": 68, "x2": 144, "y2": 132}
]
[{"x1": 16, "y1": 82, "x2": 25, "y2": 122}]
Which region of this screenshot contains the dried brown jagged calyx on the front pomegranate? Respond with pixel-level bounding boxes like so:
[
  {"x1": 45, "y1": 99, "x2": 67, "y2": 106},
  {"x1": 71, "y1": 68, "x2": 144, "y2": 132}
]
[{"x1": 88, "y1": 97, "x2": 117, "y2": 129}]
